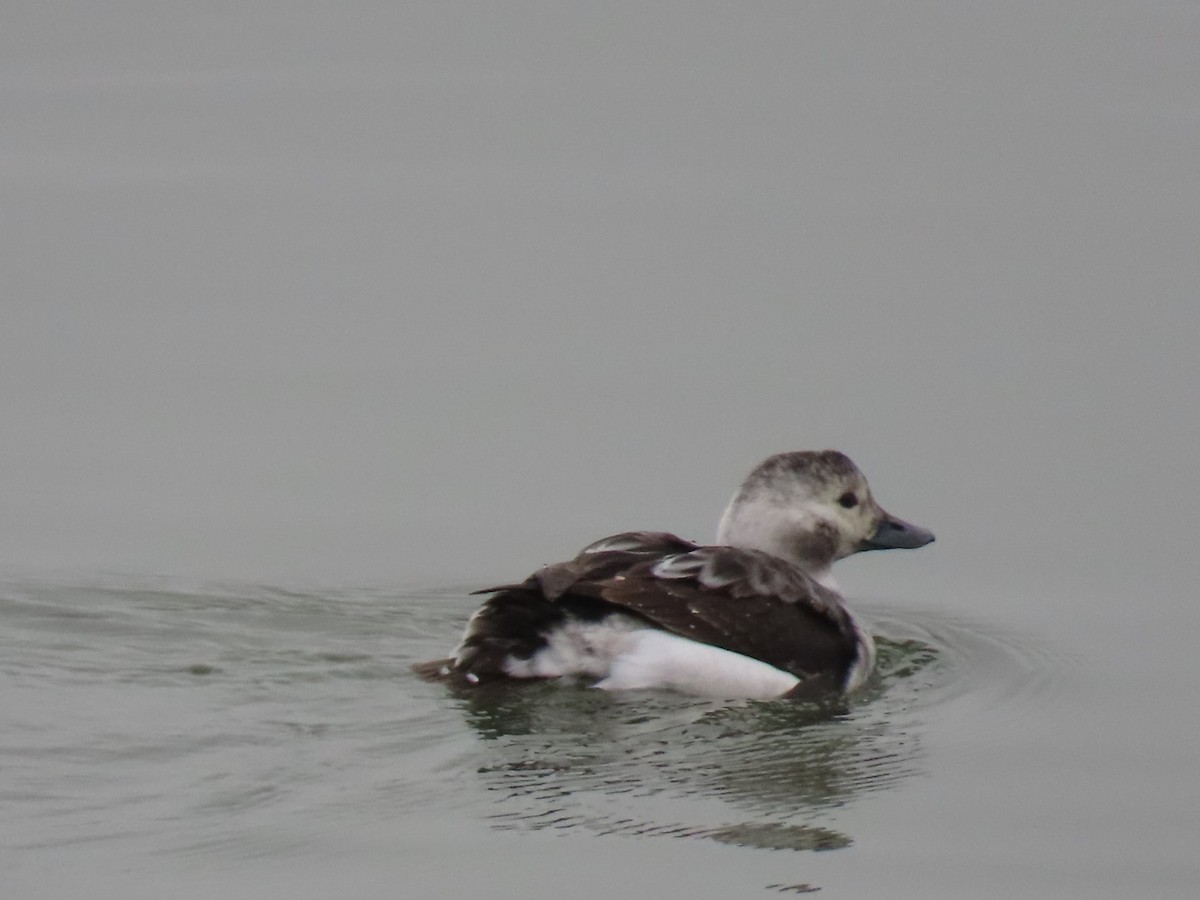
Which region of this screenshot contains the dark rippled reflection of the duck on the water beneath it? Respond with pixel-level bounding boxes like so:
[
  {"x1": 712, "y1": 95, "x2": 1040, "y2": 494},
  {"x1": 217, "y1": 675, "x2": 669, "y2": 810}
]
[{"x1": 441, "y1": 624, "x2": 947, "y2": 850}]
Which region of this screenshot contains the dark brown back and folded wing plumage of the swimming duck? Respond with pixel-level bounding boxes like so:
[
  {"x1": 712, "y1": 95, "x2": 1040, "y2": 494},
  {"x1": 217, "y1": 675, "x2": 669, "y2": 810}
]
[{"x1": 456, "y1": 532, "x2": 858, "y2": 677}]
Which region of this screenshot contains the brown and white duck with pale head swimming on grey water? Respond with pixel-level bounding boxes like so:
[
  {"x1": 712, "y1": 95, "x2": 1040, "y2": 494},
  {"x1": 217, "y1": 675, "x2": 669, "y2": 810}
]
[{"x1": 415, "y1": 450, "x2": 934, "y2": 700}]
